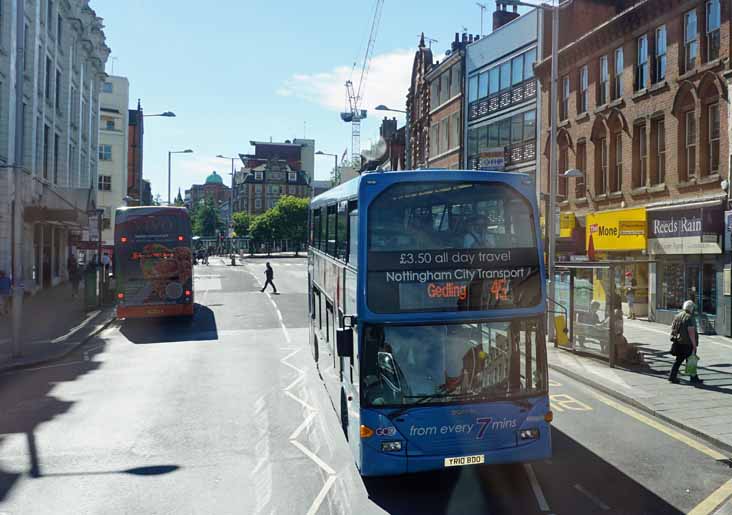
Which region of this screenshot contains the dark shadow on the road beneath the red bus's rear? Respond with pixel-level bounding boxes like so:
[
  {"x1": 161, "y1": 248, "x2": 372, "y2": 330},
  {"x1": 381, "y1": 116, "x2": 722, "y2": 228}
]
[{"x1": 120, "y1": 304, "x2": 219, "y2": 344}]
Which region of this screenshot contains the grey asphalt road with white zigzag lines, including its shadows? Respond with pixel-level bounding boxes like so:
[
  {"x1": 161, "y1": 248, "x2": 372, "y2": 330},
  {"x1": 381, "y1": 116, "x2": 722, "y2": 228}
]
[{"x1": 0, "y1": 258, "x2": 732, "y2": 515}]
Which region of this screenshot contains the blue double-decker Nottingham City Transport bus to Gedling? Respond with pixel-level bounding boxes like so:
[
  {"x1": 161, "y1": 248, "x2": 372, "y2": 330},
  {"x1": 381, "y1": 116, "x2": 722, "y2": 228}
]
[{"x1": 308, "y1": 170, "x2": 552, "y2": 476}]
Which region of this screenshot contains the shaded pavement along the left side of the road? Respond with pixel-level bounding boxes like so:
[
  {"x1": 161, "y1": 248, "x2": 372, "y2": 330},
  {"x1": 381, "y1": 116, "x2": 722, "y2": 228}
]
[{"x1": 0, "y1": 283, "x2": 114, "y2": 373}]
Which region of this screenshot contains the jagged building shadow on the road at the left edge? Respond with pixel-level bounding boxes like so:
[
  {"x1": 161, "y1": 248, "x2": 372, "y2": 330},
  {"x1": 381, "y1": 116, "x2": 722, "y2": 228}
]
[{"x1": 0, "y1": 343, "x2": 106, "y2": 502}]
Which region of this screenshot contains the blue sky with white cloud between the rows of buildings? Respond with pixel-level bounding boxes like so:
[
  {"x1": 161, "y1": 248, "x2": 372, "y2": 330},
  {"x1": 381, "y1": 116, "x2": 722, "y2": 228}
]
[{"x1": 90, "y1": 0, "x2": 528, "y2": 200}]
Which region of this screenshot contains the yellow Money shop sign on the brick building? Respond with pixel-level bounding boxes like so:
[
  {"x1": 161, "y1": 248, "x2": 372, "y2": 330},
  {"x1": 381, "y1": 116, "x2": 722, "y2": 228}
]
[{"x1": 586, "y1": 207, "x2": 646, "y2": 251}]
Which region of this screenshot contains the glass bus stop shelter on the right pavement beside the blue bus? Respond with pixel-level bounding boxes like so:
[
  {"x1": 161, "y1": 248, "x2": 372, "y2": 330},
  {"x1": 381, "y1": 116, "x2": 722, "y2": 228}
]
[{"x1": 551, "y1": 260, "x2": 648, "y2": 367}]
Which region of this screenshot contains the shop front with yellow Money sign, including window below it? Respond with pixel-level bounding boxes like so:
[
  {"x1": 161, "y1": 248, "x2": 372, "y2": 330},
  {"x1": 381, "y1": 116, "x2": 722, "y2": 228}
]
[{"x1": 585, "y1": 208, "x2": 649, "y2": 317}]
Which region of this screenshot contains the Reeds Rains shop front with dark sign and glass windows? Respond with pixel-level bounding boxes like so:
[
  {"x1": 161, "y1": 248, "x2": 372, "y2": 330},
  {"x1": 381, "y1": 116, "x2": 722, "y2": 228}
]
[{"x1": 647, "y1": 199, "x2": 728, "y2": 334}]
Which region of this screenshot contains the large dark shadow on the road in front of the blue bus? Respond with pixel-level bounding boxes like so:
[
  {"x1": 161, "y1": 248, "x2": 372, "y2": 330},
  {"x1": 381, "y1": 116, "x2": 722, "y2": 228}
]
[{"x1": 364, "y1": 428, "x2": 682, "y2": 515}]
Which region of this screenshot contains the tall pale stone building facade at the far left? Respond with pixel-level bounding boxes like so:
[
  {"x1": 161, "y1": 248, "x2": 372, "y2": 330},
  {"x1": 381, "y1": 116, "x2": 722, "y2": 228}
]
[{"x1": 0, "y1": 0, "x2": 110, "y2": 293}]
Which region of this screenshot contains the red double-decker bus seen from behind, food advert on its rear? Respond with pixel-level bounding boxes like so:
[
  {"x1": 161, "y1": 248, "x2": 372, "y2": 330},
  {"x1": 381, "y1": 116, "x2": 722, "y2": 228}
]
[{"x1": 114, "y1": 206, "x2": 193, "y2": 318}]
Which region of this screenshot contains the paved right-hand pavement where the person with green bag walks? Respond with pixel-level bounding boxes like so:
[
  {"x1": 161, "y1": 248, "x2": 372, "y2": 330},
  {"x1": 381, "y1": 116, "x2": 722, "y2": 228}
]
[{"x1": 548, "y1": 320, "x2": 732, "y2": 452}]
